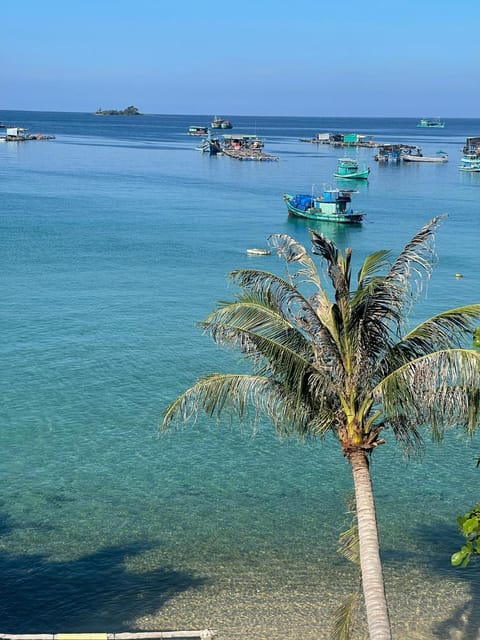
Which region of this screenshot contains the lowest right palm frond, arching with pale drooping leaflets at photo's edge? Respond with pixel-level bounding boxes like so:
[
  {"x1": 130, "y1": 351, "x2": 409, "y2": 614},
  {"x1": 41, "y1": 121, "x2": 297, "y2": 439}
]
[{"x1": 373, "y1": 349, "x2": 480, "y2": 440}]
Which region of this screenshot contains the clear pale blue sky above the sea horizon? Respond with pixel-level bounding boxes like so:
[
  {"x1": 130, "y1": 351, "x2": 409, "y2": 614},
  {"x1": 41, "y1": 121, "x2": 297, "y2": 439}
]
[{"x1": 0, "y1": 0, "x2": 480, "y2": 118}]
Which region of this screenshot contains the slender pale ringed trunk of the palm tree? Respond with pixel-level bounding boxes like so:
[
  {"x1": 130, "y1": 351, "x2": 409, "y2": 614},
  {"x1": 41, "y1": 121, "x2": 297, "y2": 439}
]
[{"x1": 349, "y1": 451, "x2": 392, "y2": 640}]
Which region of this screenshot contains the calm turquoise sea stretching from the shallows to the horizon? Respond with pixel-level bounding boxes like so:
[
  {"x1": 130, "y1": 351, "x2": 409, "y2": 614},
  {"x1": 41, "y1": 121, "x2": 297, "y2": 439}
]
[{"x1": 0, "y1": 111, "x2": 480, "y2": 640}]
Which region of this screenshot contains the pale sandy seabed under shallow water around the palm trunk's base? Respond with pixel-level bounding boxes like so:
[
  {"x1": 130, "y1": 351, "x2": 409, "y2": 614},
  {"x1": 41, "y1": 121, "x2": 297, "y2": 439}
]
[{"x1": 137, "y1": 566, "x2": 480, "y2": 640}]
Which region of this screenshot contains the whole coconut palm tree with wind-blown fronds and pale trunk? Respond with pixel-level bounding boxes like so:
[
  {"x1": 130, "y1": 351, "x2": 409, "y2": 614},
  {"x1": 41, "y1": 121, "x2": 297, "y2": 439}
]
[{"x1": 163, "y1": 216, "x2": 480, "y2": 640}]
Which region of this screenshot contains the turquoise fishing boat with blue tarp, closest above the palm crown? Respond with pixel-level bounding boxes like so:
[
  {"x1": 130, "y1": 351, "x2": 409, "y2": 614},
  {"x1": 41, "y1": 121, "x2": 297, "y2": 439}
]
[{"x1": 283, "y1": 189, "x2": 364, "y2": 224}]
